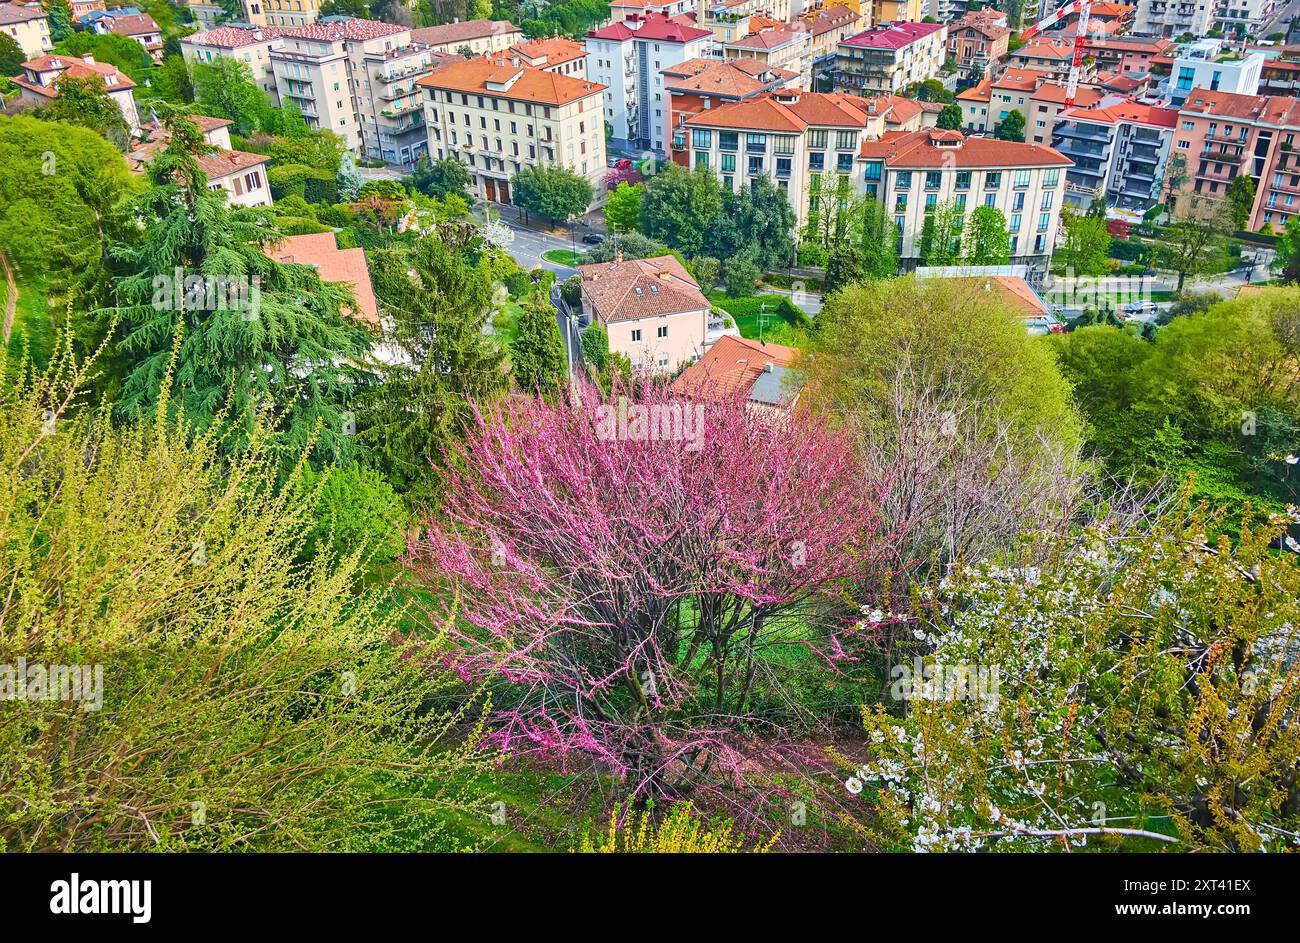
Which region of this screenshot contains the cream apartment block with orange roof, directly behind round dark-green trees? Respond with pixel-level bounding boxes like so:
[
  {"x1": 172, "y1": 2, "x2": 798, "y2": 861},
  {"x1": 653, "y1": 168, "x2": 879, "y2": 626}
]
[{"x1": 685, "y1": 90, "x2": 875, "y2": 228}]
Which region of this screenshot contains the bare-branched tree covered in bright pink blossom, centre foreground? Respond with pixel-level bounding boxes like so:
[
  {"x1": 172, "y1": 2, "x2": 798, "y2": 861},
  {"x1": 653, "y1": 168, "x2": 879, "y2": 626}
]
[{"x1": 408, "y1": 384, "x2": 892, "y2": 792}]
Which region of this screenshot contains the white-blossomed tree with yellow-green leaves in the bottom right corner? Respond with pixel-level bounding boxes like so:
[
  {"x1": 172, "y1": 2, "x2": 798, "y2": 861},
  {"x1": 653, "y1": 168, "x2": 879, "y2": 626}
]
[{"x1": 845, "y1": 515, "x2": 1300, "y2": 851}]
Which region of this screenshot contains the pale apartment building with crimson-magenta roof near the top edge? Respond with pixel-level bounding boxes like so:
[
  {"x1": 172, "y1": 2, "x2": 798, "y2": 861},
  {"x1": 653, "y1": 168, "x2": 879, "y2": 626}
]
[{"x1": 833, "y1": 22, "x2": 948, "y2": 95}]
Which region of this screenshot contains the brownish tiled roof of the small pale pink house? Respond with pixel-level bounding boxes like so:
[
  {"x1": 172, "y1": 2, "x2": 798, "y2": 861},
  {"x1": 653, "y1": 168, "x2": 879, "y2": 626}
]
[{"x1": 577, "y1": 255, "x2": 711, "y2": 324}]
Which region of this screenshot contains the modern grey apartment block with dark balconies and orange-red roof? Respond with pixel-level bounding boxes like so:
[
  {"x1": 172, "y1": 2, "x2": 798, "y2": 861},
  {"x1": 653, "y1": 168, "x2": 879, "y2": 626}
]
[{"x1": 1052, "y1": 98, "x2": 1178, "y2": 213}]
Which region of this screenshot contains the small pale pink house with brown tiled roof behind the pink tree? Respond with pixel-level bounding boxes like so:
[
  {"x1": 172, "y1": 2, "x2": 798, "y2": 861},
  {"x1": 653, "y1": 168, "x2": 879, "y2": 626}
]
[{"x1": 577, "y1": 255, "x2": 712, "y2": 373}]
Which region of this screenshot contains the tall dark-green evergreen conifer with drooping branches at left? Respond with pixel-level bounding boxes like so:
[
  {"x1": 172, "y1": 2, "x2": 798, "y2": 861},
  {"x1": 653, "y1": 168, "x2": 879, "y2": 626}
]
[{"x1": 104, "y1": 114, "x2": 373, "y2": 460}]
